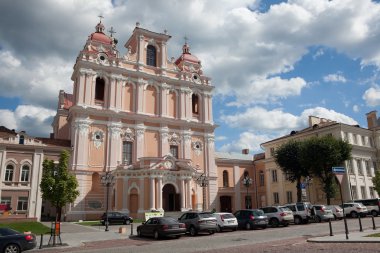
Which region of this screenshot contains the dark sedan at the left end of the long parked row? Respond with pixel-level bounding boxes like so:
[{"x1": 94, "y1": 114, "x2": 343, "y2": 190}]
[{"x1": 137, "y1": 217, "x2": 186, "y2": 239}]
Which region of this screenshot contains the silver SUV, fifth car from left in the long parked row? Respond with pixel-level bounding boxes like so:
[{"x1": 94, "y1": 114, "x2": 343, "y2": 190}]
[{"x1": 260, "y1": 206, "x2": 294, "y2": 227}]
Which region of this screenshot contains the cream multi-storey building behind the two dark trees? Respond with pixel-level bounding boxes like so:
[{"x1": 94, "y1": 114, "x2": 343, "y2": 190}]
[{"x1": 262, "y1": 111, "x2": 380, "y2": 204}]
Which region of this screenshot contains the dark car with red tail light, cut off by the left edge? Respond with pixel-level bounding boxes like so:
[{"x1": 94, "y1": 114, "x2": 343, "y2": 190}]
[{"x1": 0, "y1": 228, "x2": 37, "y2": 253}]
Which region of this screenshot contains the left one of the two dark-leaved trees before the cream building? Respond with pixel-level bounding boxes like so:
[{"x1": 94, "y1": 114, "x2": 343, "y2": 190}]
[{"x1": 274, "y1": 140, "x2": 309, "y2": 202}]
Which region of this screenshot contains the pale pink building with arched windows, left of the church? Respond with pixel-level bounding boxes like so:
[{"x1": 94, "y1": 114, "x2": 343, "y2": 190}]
[{"x1": 0, "y1": 126, "x2": 70, "y2": 220}]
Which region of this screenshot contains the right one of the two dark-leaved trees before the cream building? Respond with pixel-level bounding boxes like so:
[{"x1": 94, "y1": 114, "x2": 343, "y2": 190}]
[{"x1": 300, "y1": 135, "x2": 352, "y2": 205}]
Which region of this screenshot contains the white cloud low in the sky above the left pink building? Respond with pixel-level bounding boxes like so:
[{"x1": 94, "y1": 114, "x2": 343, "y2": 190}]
[{"x1": 0, "y1": 105, "x2": 55, "y2": 137}]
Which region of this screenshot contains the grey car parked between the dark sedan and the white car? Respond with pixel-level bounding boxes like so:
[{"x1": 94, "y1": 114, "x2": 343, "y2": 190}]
[{"x1": 178, "y1": 212, "x2": 217, "y2": 236}]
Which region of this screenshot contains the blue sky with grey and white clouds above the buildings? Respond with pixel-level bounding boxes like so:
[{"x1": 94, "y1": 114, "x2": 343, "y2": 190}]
[{"x1": 0, "y1": 0, "x2": 380, "y2": 153}]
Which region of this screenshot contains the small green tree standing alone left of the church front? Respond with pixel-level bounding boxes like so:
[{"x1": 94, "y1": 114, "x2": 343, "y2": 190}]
[{"x1": 40, "y1": 150, "x2": 79, "y2": 221}]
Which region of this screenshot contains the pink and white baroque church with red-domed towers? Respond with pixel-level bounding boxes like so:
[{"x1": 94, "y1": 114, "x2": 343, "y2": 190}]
[{"x1": 52, "y1": 21, "x2": 265, "y2": 220}]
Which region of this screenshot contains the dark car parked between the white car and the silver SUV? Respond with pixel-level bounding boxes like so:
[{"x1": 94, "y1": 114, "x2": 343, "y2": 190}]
[{"x1": 234, "y1": 209, "x2": 268, "y2": 230}]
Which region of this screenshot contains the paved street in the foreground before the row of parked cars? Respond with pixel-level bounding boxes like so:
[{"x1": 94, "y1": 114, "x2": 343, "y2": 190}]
[{"x1": 31, "y1": 217, "x2": 380, "y2": 253}]
